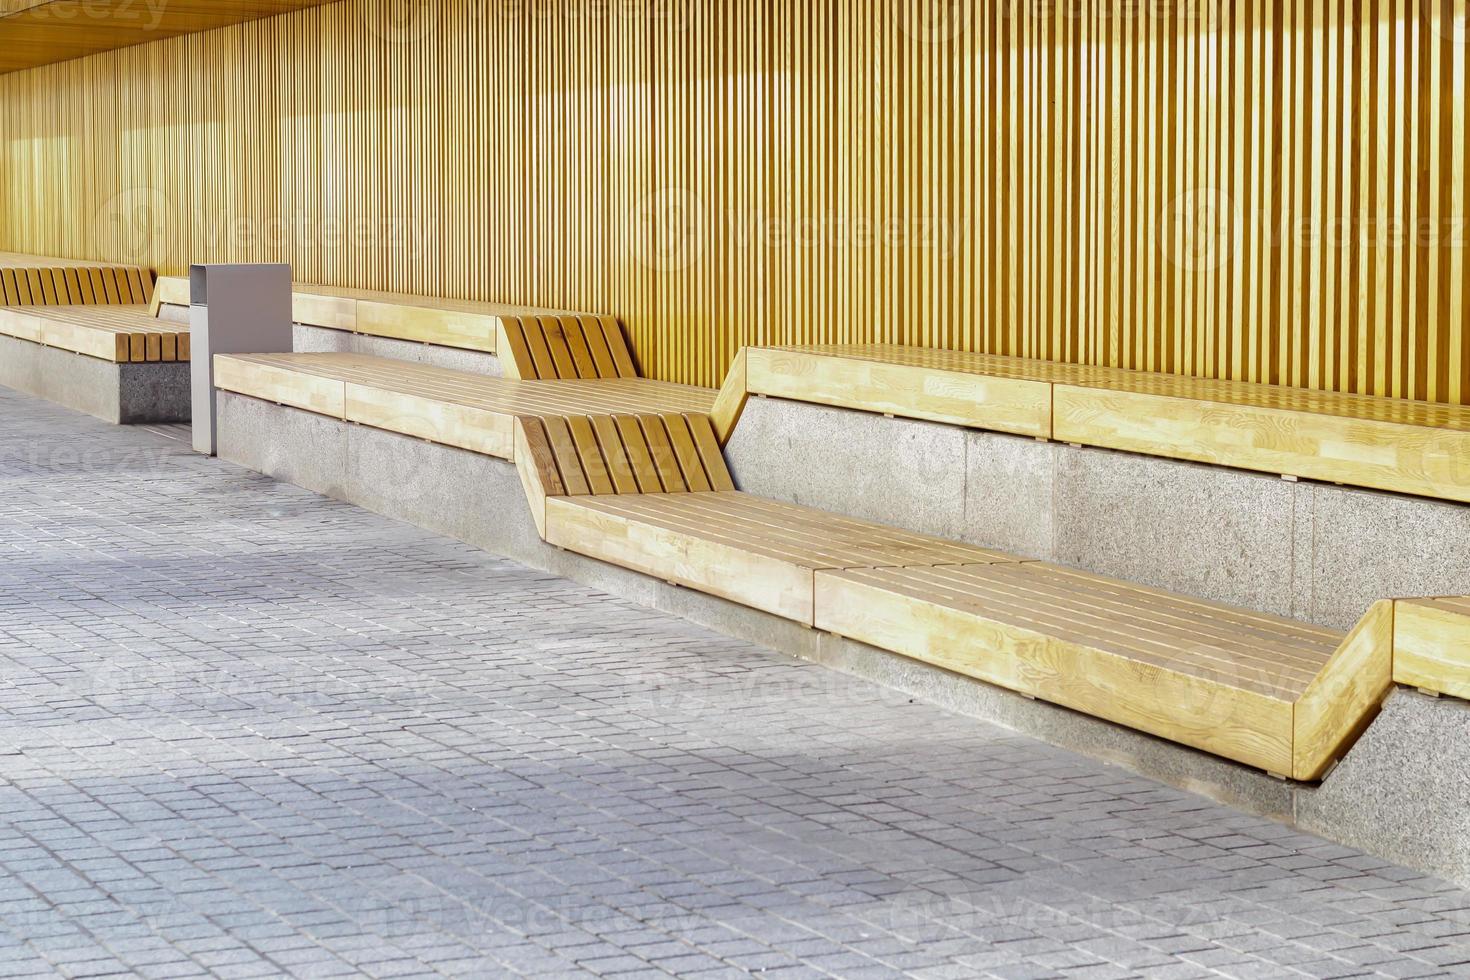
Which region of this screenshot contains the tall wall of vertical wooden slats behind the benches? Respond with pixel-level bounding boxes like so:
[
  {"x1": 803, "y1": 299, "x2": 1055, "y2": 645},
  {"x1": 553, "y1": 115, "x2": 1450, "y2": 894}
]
[{"x1": 0, "y1": 0, "x2": 1470, "y2": 403}]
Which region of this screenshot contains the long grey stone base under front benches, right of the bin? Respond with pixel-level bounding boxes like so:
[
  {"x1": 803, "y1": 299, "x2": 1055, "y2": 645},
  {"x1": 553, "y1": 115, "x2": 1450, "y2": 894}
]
[{"x1": 219, "y1": 392, "x2": 1470, "y2": 884}]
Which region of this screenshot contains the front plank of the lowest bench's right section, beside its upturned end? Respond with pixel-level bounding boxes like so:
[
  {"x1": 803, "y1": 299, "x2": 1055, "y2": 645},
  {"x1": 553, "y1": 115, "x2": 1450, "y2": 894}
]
[{"x1": 814, "y1": 570, "x2": 1292, "y2": 774}]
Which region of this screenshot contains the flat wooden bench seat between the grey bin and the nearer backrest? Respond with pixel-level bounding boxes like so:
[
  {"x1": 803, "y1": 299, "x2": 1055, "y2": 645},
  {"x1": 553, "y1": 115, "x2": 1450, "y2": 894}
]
[{"x1": 215, "y1": 354, "x2": 714, "y2": 460}]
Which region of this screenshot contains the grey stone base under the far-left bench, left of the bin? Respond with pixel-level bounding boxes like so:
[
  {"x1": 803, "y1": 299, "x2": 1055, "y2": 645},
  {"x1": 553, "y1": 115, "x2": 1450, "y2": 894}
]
[{"x1": 0, "y1": 336, "x2": 191, "y2": 425}]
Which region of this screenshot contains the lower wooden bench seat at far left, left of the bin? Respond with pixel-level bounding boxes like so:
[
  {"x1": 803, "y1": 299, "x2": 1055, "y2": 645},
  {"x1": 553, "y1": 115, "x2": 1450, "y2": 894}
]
[{"x1": 0, "y1": 306, "x2": 190, "y2": 364}]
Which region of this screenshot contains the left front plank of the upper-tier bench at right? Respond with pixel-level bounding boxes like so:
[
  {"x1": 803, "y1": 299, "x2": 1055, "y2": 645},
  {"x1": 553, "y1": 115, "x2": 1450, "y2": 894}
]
[{"x1": 752, "y1": 347, "x2": 1051, "y2": 438}]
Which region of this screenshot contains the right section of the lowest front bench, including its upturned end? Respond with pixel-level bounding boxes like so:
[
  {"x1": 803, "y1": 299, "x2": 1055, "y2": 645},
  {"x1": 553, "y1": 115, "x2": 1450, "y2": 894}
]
[{"x1": 816, "y1": 563, "x2": 1392, "y2": 780}]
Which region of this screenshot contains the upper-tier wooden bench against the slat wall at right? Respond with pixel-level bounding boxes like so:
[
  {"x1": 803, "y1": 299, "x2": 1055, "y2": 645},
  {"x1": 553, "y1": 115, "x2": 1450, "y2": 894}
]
[{"x1": 726, "y1": 347, "x2": 1470, "y2": 502}]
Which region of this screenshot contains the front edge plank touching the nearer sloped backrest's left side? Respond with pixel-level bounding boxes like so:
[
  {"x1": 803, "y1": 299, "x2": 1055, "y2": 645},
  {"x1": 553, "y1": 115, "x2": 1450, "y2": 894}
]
[{"x1": 344, "y1": 382, "x2": 515, "y2": 460}]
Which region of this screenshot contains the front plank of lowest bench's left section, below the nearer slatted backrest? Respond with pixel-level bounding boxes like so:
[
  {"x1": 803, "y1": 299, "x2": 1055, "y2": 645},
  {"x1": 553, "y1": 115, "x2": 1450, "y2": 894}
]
[{"x1": 547, "y1": 497, "x2": 811, "y2": 626}]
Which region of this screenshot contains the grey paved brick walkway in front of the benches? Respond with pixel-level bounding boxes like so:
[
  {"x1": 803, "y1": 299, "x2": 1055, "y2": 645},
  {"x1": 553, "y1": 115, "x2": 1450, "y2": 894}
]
[{"x1": 0, "y1": 389, "x2": 1470, "y2": 979}]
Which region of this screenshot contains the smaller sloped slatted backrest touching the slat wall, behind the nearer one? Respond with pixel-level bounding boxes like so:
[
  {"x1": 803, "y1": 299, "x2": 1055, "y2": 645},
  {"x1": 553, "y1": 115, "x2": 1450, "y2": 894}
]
[{"x1": 498, "y1": 316, "x2": 638, "y2": 381}]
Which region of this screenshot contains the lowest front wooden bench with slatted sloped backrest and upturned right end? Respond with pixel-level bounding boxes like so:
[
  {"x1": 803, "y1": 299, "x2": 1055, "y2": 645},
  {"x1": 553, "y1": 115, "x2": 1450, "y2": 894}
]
[{"x1": 516, "y1": 419, "x2": 1394, "y2": 780}]
